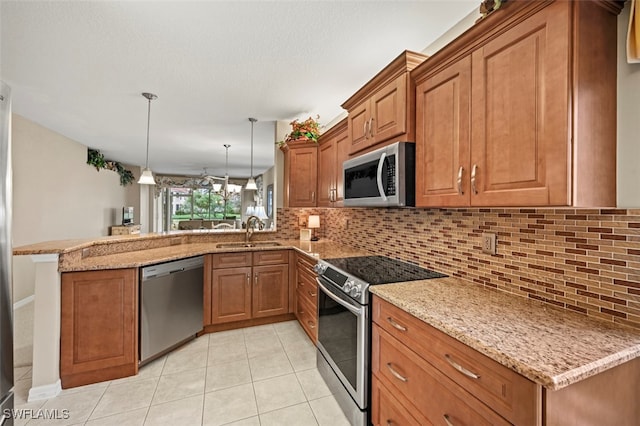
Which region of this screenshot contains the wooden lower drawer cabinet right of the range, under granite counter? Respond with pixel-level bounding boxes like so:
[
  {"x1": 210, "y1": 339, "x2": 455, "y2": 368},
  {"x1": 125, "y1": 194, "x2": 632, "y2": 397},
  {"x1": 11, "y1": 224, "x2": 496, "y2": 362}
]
[{"x1": 371, "y1": 296, "x2": 640, "y2": 426}]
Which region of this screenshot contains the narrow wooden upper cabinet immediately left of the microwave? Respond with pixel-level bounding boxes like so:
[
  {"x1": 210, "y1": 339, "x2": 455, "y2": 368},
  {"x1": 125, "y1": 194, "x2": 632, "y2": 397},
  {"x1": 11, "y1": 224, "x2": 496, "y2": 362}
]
[{"x1": 318, "y1": 118, "x2": 349, "y2": 207}]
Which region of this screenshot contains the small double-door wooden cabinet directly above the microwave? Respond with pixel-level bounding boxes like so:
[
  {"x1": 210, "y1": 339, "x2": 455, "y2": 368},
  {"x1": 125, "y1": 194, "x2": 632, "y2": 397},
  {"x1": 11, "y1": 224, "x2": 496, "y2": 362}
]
[{"x1": 342, "y1": 51, "x2": 427, "y2": 154}]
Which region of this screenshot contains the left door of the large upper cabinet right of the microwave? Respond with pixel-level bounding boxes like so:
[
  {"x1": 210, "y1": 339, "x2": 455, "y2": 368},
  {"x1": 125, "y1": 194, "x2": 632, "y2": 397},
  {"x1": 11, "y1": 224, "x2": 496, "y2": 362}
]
[{"x1": 416, "y1": 57, "x2": 471, "y2": 207}]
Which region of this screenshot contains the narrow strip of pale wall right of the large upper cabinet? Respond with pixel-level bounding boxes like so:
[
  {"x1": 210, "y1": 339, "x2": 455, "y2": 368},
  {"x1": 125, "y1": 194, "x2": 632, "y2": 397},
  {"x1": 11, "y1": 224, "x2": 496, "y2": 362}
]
[{"x1": 618, "y1": 2, "x2": 640, "y2": 208}]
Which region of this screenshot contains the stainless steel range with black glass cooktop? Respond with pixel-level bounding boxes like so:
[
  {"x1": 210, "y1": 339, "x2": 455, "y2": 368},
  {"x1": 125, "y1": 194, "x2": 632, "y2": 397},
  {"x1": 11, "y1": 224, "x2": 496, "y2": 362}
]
[{"x1": 314, "y1": 256, "x2": 446, "y2": 425}]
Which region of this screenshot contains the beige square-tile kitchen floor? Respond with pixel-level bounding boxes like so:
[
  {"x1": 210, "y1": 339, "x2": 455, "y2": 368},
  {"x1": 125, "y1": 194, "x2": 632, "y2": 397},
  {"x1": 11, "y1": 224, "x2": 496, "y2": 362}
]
[{"x1": 15, "y1": 321, "x2": 349, "y2": 426}]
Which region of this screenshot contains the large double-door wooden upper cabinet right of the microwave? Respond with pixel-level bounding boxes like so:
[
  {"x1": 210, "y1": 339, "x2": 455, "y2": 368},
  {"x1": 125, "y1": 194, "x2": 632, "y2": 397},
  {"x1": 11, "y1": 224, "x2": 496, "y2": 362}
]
[{"x1": 412, "y1": 1, "x2": 620, "y2": 207}]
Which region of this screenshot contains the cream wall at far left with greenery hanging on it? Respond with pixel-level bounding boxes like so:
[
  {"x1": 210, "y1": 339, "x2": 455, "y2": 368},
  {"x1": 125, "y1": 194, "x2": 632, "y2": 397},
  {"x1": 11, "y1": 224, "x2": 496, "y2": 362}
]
[{"x1": 12, "y1": 114, "x2": 140, "y2": 302}]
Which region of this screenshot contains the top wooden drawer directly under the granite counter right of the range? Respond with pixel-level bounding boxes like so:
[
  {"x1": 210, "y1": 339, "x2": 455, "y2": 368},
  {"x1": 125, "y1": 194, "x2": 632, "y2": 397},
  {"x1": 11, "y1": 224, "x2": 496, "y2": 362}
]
[{"x1": 373, "y1": 297, "x2": 539, "y2": 424}]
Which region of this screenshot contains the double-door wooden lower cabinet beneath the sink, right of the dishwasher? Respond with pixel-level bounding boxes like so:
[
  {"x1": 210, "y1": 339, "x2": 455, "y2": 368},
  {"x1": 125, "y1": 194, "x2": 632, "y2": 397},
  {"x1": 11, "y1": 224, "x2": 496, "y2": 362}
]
[{"x1": 204, "y1": 250, "x2": 289, "y2": 326}]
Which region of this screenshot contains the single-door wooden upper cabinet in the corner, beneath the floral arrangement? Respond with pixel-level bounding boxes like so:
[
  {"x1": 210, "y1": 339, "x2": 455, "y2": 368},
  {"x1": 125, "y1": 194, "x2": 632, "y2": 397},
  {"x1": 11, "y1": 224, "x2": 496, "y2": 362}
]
[{"x1": 283, "y1": 141, "x2": 318, "y2": 207}]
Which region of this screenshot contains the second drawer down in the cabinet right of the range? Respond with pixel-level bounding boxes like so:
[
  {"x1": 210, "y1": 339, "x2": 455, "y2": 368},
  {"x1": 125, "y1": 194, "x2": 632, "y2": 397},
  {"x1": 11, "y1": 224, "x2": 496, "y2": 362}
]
[{"x1": 371, "y1": 325, "x2": 510, "y2": 426}]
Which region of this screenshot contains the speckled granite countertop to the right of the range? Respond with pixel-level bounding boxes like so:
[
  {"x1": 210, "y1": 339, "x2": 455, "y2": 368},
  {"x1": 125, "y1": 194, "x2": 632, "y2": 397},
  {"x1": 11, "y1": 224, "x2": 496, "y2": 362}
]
[{"x1": 370, "y1": 277, "x2": 640, "y2": 390}]
